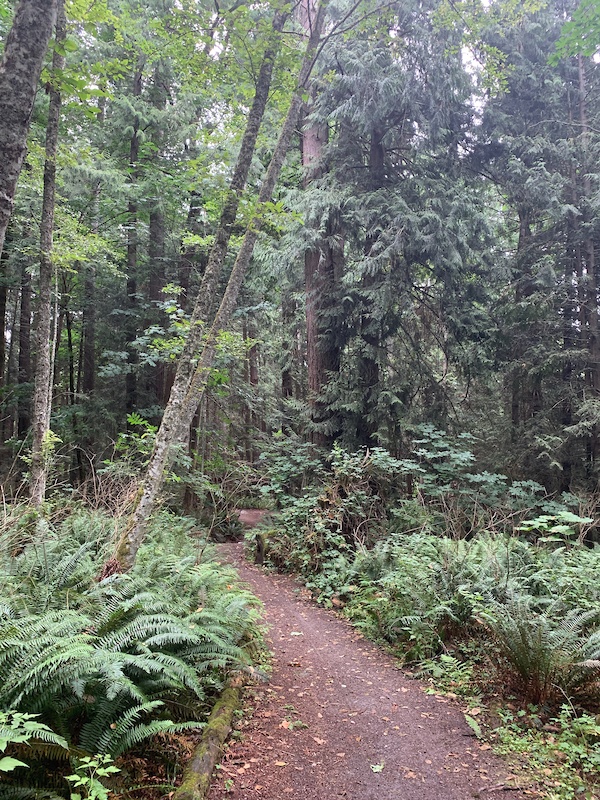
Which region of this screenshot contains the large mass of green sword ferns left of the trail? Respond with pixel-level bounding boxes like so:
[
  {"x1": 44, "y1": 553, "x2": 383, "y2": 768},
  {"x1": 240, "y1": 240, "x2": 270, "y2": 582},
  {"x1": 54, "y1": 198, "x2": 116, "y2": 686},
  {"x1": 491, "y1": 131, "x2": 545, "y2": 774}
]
[{"x1": 0, "y1": 508, "x2": 258, "y2": 798}]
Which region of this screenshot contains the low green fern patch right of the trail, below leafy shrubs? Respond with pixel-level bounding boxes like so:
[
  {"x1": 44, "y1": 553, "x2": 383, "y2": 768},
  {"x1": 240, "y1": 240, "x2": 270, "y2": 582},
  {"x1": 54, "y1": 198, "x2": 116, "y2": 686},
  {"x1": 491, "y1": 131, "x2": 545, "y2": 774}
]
[{"x1": 290, "y1": 533, "x2": 600, "y2": 702}]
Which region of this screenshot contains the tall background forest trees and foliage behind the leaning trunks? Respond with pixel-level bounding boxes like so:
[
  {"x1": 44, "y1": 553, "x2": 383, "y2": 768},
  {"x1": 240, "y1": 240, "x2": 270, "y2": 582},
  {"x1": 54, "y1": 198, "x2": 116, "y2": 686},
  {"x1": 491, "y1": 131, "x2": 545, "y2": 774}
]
[{"x1": 0, "y1": 0, "x2": 600, "y2": 500}]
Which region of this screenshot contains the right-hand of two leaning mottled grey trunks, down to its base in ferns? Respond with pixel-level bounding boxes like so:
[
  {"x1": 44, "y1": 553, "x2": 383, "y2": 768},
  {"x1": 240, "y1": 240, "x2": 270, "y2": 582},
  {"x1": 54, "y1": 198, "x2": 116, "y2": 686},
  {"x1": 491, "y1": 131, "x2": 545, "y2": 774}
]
[{"x1": 115, "y1": 2, "x2": 326, "y2": 569}]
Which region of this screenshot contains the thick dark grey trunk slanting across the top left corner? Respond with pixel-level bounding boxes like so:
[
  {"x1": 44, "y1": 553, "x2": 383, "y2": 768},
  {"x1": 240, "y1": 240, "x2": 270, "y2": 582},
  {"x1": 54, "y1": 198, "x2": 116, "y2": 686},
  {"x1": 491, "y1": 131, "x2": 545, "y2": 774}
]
[{"x1": 0, "y1": 0, "x2": 57, "y2": 254}]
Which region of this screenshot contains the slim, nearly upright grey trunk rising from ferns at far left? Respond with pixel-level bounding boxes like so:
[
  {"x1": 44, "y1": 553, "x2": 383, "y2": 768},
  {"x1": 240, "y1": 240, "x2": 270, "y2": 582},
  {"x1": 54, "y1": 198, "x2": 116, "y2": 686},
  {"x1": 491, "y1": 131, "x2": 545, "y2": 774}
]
[{"x1": 31, "y1": 0, "x2": 67, "y2": 508}]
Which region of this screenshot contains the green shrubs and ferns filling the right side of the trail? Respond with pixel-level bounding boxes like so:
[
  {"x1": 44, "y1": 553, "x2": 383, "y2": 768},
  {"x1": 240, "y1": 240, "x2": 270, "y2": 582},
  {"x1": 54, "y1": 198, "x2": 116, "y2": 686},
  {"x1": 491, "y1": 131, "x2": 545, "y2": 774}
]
[{"x1": 253, "y1": 434, "x2": 600, "y2": 800}]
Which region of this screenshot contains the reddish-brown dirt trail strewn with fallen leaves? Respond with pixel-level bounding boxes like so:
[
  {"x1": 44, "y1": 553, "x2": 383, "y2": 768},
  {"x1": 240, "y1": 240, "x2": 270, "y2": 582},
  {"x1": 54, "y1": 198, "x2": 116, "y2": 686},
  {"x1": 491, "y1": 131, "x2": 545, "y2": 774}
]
[{"x1": 209, "y1": 544, "x2": 531, "y2": 800}]
